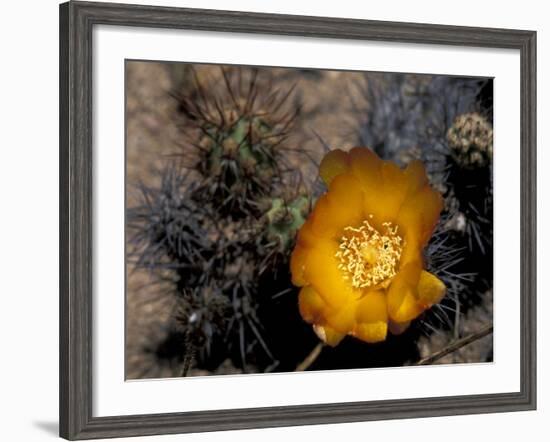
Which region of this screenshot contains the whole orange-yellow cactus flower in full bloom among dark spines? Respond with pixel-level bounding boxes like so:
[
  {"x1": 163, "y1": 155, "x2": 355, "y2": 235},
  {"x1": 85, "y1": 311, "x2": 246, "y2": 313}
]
[{"x1": 290, "y1": 147, "x2": 446, "y2": 346}]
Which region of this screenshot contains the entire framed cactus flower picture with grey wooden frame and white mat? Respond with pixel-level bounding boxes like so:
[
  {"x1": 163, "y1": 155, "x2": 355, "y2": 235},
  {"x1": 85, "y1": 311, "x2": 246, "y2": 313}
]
[{"x1": 60, "y1": 2, "x2": 536, "y2": 440}]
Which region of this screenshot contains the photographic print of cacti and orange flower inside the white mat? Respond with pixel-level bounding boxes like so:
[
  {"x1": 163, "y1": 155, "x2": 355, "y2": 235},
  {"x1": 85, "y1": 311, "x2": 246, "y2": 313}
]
[{"x1": 125, "y1": 60, "x2": 493, "y2": 380}]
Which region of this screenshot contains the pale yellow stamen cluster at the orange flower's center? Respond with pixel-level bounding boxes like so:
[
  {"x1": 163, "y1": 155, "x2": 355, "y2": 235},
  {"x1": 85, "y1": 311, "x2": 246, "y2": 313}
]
[{"x1": 336, "y1": 216, "x2": 403, "y2": 288}]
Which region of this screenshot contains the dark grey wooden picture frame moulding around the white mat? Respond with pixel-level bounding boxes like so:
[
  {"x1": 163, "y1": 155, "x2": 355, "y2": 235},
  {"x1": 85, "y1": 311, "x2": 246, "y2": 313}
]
[{"x1": 60, "y1": 2, "x2": 536, "y2": 440}]
